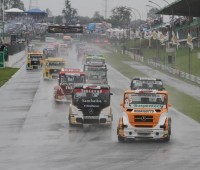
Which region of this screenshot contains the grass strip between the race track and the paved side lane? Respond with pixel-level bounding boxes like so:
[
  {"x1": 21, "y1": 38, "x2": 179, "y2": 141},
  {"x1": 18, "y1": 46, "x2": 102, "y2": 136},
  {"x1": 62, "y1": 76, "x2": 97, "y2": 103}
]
[{"x1": 105, "y1": 50, "x2": 200, "y2": 122}]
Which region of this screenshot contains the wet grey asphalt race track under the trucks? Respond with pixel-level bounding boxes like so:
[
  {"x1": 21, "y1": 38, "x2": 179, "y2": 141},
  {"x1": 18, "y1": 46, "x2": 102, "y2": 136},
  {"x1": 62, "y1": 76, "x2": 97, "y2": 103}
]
[{"x1": 0, "y1": 41, "x2": 200, "y2": 170}]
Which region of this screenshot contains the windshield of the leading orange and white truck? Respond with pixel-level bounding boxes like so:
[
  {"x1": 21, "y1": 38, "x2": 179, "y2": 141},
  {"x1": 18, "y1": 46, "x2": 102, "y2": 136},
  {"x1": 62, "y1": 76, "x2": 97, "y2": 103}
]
[{"x1": 124, "y1": 93, "x2": 166, "y2": 108}]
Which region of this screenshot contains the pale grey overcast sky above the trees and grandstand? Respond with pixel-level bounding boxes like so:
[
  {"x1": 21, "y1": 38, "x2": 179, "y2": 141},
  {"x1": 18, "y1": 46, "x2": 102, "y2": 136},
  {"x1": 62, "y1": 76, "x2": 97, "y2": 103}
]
[{"x1": 22, "y1": 0, "x2": 175, "y2": 19}]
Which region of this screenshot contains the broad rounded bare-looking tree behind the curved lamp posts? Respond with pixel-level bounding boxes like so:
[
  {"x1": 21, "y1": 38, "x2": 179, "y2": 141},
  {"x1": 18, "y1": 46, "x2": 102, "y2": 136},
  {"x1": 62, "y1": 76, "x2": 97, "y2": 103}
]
[{"x1": 111, "y1": 6, "x2": 132, "y2": 28}]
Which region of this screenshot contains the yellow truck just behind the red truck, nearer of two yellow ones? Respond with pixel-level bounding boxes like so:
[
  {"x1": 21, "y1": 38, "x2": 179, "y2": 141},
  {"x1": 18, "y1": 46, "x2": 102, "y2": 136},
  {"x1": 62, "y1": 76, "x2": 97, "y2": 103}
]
[{"x1": 43, "y1": 58, "x2": 65, "y2": 80}]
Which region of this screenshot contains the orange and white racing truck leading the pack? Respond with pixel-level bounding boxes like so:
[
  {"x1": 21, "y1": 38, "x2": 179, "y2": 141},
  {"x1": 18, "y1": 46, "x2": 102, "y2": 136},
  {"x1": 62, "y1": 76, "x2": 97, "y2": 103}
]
[{"x1": 117, "y1": 90, "x2": 171, "y2": 142}]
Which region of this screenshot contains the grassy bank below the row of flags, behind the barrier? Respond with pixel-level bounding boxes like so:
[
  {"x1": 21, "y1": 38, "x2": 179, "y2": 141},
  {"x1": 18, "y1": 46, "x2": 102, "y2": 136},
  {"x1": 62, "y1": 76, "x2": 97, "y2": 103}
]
[{"x1": 119, "y1": 39, "x2": 200, "y2": 77}]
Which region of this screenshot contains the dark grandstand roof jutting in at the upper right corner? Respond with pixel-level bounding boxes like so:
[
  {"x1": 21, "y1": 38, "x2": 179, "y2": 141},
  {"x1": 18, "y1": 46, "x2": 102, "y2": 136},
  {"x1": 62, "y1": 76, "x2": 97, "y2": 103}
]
[{"x1": 157, "y1": 0, "x2": 200, "y2": 17}]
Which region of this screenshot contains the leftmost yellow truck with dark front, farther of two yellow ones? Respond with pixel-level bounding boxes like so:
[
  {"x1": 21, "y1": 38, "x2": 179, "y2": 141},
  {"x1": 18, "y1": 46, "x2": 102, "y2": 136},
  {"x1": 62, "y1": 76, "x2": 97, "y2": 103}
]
[{"x1": 26, "y1": 51, "x2": 44, "y2": 70}]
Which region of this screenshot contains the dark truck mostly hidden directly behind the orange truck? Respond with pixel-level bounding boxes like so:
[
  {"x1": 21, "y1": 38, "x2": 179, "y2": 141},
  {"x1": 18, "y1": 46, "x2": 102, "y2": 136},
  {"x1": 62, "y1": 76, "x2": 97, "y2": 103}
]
[{"x1": 130, "y1": 77, "x2": 165, "y2": 91}]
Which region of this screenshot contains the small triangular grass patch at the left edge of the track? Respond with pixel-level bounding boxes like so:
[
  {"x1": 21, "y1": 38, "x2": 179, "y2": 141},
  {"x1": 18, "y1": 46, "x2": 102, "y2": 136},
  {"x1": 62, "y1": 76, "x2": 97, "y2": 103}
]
[{"x1": 0, "y1": 67, "x2": 19, "y2": 87}]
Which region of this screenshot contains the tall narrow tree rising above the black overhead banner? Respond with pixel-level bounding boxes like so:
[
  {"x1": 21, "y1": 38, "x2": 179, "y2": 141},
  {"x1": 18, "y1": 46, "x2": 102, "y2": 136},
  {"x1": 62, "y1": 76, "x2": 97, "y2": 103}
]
[{"x1": 62, "y1": 0, "x2": 78, "y2": 24}]
